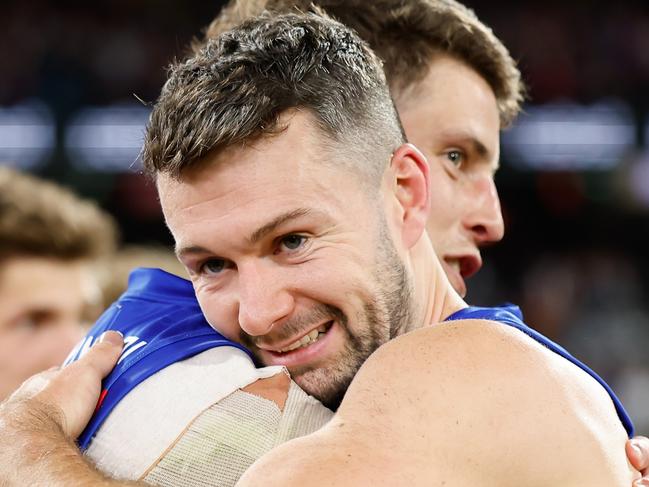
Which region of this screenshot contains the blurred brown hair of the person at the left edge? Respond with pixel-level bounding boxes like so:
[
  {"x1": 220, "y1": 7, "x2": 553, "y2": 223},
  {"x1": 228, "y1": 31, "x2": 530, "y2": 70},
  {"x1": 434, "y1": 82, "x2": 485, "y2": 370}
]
[{"x1": 0, "y1": 167, "x2": 117, "y2": 261}]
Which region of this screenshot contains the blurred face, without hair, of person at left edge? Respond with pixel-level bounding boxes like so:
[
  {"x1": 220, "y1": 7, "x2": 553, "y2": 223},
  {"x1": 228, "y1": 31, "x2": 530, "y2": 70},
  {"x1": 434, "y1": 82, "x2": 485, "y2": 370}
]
[{"x1": 0, "y1": 257, "x2": 93, "y2": 400}]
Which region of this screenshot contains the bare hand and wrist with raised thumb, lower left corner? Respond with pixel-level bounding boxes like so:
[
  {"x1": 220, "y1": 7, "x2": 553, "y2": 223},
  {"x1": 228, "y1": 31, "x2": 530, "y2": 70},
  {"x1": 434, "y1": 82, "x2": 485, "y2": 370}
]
[{"x1": 0, "y1": 333, "x2": 137, "y2": 486}]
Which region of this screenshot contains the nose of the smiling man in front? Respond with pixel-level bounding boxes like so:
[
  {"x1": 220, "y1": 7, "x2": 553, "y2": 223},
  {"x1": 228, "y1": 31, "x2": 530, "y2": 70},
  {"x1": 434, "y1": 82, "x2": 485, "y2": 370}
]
[{"x1": 238, "y1": 262, "x2": 295, "y2": 336}]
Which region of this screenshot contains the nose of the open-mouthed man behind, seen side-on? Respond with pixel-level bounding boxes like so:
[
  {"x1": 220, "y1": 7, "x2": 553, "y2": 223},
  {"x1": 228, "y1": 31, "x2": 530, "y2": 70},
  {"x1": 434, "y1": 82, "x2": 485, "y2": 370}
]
[{"x1": 464, "y1": 178, "x2": 505, "y2": 245}]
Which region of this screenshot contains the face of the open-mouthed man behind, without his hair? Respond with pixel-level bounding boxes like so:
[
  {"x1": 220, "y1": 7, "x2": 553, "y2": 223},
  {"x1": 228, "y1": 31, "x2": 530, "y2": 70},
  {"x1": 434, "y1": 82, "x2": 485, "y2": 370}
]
[{"x1": 395, "y1": 55, "x2": 504, "y2": 296}]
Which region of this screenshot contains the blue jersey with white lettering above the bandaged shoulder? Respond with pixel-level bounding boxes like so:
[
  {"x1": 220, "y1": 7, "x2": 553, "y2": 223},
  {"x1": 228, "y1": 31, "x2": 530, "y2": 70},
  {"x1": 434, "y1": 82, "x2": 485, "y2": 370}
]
[{"x1": 64, "y1": 269, "x2": 249, "y2": 449}]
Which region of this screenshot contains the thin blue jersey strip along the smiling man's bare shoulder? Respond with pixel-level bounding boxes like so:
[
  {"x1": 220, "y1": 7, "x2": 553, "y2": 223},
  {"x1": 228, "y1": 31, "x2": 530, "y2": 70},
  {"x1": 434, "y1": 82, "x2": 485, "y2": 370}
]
[{"x1": 447, "y1": 305, "x2": 634, "y2": 437}]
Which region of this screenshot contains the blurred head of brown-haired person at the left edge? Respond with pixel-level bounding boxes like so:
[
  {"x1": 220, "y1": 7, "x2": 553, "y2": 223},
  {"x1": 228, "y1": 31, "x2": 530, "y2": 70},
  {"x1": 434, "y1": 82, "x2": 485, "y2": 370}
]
[{"x1": 0, "y1": 167, "x2": 117, "y2": 400}]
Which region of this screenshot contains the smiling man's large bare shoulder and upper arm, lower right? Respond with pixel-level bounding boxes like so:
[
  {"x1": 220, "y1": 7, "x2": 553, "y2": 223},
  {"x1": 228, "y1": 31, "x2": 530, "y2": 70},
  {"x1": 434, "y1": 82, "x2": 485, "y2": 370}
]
[{"x1": 240, "y1": 322, "x2": 634, "y2": 487}]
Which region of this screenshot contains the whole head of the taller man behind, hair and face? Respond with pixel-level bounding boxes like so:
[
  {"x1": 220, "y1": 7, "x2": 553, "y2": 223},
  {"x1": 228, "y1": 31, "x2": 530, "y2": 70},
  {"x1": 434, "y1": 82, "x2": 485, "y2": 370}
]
[{"x1": 202, "y1": 0, "x2": 525, "y2": 296}]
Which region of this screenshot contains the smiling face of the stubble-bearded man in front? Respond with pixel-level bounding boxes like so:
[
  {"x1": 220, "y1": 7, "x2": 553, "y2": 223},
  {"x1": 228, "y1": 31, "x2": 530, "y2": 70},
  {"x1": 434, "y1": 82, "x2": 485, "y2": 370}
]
[{"x1": 158, "y1": 113, "x2": 425, "y2": 407}]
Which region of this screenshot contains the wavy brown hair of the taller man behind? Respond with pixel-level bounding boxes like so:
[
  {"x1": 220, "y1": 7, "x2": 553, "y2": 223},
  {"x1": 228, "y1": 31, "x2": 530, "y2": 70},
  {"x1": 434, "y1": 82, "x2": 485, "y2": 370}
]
[{"x1": 200, "y1": 0, "x2": 526, "y2": 128}]
